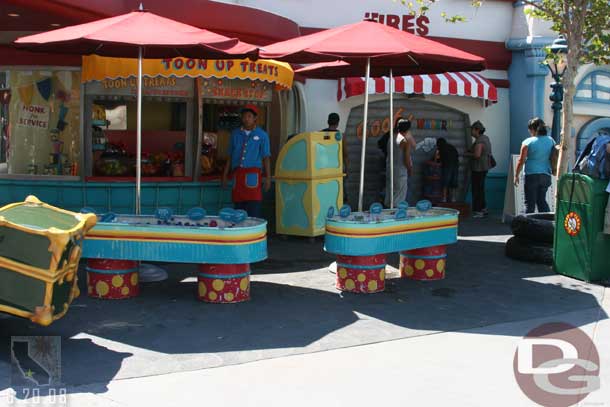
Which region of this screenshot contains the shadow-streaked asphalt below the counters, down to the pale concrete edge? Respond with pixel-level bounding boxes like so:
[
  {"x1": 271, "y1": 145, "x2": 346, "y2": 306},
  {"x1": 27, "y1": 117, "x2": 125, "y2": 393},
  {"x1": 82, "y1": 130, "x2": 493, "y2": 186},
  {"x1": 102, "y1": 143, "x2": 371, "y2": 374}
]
[{"x1": 0, "y1": 218, "x2": 607, "y2": 392}]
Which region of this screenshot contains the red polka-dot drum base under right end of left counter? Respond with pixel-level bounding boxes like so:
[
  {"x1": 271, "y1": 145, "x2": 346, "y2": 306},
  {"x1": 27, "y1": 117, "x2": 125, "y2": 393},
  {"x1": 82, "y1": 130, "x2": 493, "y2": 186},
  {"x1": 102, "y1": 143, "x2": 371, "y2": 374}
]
[{"x1": 197, "y1": 264, "x2": 250, "y2": 304}]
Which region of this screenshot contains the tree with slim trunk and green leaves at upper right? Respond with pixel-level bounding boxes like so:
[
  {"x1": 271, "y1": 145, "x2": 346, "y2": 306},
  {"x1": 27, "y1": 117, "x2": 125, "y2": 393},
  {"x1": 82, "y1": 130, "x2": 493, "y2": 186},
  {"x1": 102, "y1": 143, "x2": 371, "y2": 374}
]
[{"x1": 395, "y1": 0, "x2": 610, "y2": 174}]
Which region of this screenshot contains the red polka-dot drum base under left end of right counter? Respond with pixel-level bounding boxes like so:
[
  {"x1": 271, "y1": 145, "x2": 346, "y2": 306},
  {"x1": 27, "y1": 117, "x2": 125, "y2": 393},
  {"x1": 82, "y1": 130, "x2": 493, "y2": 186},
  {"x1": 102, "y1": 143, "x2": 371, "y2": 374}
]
[{"x1": 336, "y1": 255, "x2": 386, "y2": 294}]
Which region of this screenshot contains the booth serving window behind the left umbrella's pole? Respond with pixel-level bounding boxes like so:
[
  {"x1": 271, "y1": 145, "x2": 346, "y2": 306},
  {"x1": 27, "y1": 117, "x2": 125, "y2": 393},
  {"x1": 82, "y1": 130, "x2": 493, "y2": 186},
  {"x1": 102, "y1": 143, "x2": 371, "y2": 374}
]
[{"x1": 85, "y1": 78, "x2": 195, "y2": 179}]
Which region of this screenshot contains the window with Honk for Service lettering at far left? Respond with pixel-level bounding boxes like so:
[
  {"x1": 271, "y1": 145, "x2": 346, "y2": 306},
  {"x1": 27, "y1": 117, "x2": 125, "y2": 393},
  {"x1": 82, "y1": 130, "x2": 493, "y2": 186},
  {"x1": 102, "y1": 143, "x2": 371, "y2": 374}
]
[{"x1": 0, "y1": 68, "x2": 81, "y2": 175}]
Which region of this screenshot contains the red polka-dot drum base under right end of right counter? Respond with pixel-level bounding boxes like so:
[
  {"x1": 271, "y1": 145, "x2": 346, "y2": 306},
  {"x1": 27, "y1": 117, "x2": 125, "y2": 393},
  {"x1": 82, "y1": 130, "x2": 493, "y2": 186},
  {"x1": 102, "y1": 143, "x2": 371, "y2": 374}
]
[{"x1": 399, "y1": 246, "x2": 447, "y2": 281}]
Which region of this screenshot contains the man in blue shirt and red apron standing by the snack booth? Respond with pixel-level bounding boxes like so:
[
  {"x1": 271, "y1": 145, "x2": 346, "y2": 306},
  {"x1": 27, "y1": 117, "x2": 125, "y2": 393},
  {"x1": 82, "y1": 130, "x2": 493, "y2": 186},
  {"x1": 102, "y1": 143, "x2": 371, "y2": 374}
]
[{"x1": 222, "y1": 105, "x2": 271, "y2": 218}]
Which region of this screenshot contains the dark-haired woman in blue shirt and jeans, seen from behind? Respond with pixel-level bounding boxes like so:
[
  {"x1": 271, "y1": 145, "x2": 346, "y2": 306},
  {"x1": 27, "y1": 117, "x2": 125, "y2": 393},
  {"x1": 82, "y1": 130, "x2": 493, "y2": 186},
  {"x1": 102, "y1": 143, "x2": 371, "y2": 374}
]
[{"x1": 515, "y1": 117, "x2": 555, "y2": 213}]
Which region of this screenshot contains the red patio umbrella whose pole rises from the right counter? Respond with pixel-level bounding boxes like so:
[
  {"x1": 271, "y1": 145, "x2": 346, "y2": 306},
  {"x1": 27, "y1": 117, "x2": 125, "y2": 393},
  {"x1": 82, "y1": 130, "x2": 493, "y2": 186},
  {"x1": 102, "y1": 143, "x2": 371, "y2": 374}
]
[{"x1": 261, "y1": 21, "x2": 485, "y2": 211}]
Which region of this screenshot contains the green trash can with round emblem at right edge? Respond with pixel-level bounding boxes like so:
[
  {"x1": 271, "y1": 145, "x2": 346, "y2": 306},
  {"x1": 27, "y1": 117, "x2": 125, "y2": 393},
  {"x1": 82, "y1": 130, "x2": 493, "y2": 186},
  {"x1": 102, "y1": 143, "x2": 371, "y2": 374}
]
[{"x1": 553, "y1": 173, "x2": 610, "y2": 282}]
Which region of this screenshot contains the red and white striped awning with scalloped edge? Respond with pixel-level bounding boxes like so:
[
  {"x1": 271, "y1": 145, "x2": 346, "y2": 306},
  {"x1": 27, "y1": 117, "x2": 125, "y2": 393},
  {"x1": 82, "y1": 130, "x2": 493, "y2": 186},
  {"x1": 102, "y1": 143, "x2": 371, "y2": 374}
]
[{"x1": 337, "y1": 72, "x2": 498, "y2": 103}]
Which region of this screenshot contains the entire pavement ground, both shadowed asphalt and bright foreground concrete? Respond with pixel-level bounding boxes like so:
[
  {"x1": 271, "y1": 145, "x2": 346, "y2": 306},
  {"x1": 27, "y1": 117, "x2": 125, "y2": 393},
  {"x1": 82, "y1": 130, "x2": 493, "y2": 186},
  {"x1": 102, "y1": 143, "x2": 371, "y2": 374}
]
[{"x1": 0, "y1": 218, "x2": 610, "y2": 406}]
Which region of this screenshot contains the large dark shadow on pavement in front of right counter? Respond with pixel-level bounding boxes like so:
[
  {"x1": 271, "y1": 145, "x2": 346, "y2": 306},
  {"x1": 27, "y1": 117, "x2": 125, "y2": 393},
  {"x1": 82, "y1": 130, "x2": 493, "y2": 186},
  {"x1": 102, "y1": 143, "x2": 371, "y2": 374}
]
[{"x1": 346, "y1": 241, "x2": 607, "y2": 336}]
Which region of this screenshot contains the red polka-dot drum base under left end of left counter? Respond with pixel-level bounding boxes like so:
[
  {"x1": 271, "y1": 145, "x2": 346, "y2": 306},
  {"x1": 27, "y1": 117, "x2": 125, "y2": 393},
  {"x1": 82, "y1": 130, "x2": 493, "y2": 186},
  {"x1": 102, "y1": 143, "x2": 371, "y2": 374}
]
[{"x1": 86, "y1": 259, "x2": 140, "y2": 300}]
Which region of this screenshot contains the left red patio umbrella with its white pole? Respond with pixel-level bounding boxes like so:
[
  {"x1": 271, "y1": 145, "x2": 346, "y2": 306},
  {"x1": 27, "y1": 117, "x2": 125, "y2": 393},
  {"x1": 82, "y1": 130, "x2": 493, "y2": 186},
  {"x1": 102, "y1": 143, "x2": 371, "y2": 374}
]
[{"x1": 14, "y1": 5, "x2": 258, "y2": 214}]
